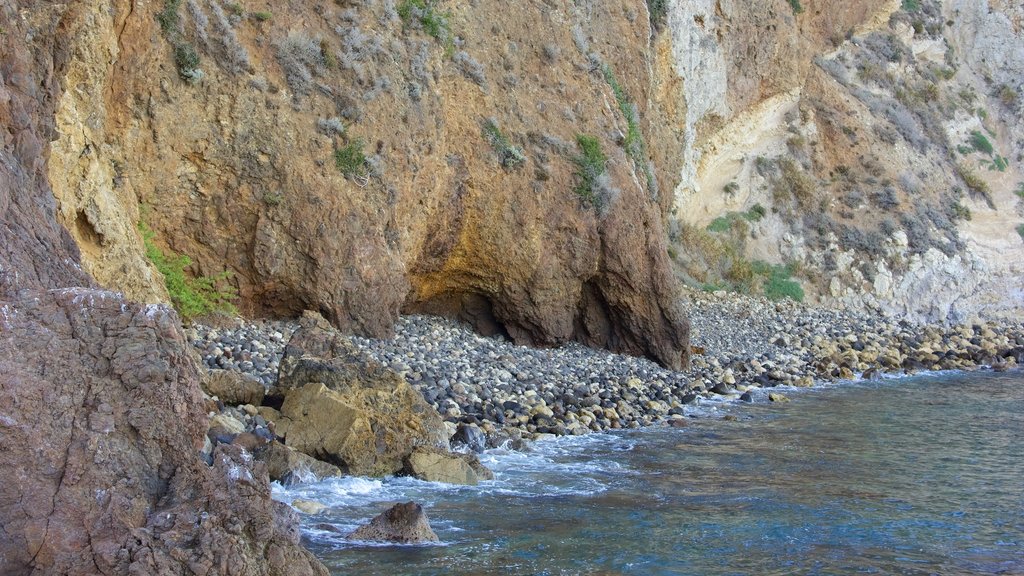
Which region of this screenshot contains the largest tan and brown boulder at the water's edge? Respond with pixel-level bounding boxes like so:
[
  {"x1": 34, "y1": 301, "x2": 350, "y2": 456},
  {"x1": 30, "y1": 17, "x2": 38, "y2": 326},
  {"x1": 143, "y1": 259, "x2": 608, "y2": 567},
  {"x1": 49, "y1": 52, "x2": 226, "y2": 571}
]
[{"x1": 278, "y1": 314, "x2": 449, "y2": 476}]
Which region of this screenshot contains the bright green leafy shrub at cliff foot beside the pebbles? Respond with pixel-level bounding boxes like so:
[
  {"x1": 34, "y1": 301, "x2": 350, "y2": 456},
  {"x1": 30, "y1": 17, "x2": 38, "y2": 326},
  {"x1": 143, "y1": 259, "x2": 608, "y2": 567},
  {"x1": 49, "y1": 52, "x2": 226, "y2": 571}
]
[{"x1": 138, "y1": 220, "x2": 238, "y2": 320}]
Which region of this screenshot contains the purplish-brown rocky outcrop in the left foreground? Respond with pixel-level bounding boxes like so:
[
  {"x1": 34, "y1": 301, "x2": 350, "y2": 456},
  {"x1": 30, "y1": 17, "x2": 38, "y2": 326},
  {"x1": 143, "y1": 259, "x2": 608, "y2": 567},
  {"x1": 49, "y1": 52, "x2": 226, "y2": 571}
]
[{"x1": 0, "y1": 0, "x2": 327, "y2": 575}]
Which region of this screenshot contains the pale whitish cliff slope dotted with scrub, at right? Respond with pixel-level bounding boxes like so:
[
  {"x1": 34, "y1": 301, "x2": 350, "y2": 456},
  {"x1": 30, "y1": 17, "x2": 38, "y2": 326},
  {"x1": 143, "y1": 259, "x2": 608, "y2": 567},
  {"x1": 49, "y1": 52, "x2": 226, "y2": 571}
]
[{"x1": 669, "y1": 0, "x2": 1024, "y2": 322}]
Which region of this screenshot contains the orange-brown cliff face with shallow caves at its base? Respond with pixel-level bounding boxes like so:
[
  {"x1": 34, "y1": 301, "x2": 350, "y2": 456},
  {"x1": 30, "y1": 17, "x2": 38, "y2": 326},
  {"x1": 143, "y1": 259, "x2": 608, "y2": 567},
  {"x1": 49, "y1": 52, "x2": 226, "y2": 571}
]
[{"x1": 41, "y1": 0, "x2": 687, "y2": 366}]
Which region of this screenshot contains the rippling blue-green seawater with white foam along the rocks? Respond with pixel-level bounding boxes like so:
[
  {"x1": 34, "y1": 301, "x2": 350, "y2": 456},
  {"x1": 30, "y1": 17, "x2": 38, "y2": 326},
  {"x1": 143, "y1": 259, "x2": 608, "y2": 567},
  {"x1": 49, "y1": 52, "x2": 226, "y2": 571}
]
[{"x1": 276, "y1": 372, "x2": 1024, "y2": 576}]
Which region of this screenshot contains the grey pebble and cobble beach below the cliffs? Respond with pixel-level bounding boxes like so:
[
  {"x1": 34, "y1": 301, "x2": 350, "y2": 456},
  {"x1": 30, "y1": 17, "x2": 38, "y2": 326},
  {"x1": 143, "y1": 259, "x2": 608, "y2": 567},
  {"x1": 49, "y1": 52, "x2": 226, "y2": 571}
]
[{"x1": 189, "y1": 293, "x2": 1024, "y2": 451}]
